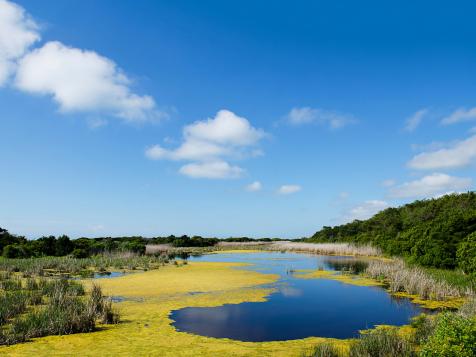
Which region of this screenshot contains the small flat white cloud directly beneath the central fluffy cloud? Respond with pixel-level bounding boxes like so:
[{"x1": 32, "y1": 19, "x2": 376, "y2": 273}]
[{"x1": 179, "y1": 161, "x2": 244, "y2": 179}]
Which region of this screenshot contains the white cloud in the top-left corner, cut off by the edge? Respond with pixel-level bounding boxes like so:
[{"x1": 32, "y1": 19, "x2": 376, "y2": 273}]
[{"x1": 0, "y1": 0, "x2": 40, "y2": 86}]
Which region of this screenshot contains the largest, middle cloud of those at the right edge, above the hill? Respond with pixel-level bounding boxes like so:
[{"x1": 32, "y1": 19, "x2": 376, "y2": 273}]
[{"x1": 408, "y1": 135, "x2": 476, "y2": 170}]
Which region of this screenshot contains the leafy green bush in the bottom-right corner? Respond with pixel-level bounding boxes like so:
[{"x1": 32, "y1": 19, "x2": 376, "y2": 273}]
[{"x1": 420, "y1": 313, "x2": 476, "y2": 357}]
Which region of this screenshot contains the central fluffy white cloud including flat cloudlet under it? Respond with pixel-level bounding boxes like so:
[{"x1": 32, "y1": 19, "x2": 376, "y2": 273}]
[{"x1": 145, "y1": 110, "x2": 265, "y2": 178}]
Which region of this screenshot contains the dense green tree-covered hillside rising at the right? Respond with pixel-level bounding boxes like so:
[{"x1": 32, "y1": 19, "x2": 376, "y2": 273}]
[{"x1": 306, "y1": 192, "x2": 476, "y2": 273}]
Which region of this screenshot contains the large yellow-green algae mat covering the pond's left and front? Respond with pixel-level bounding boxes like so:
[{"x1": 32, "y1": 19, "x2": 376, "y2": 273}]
[{"x1": 0, "y1": 262, "x2": 349, "y2": 357}]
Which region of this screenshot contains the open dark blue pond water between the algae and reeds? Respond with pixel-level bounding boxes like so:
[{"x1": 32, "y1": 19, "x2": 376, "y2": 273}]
[{"x1": 171, "y1": 253, "x2": 423, "y2": 342}]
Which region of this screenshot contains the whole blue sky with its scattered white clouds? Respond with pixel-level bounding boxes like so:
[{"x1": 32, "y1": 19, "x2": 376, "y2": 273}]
[{"x1": 0, "y1": 0, "x2": 476, "y2": 238}]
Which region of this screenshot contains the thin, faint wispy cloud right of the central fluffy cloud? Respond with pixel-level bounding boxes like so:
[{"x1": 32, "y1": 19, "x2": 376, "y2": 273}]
[{"x1": 286, "y1": 107, "x2": 356, "y2": 129}]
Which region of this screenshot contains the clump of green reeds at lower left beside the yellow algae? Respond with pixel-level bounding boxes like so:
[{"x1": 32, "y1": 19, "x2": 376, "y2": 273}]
[{"x1": 0, "y1": 273, "x2": 119, "y2": 345}]
